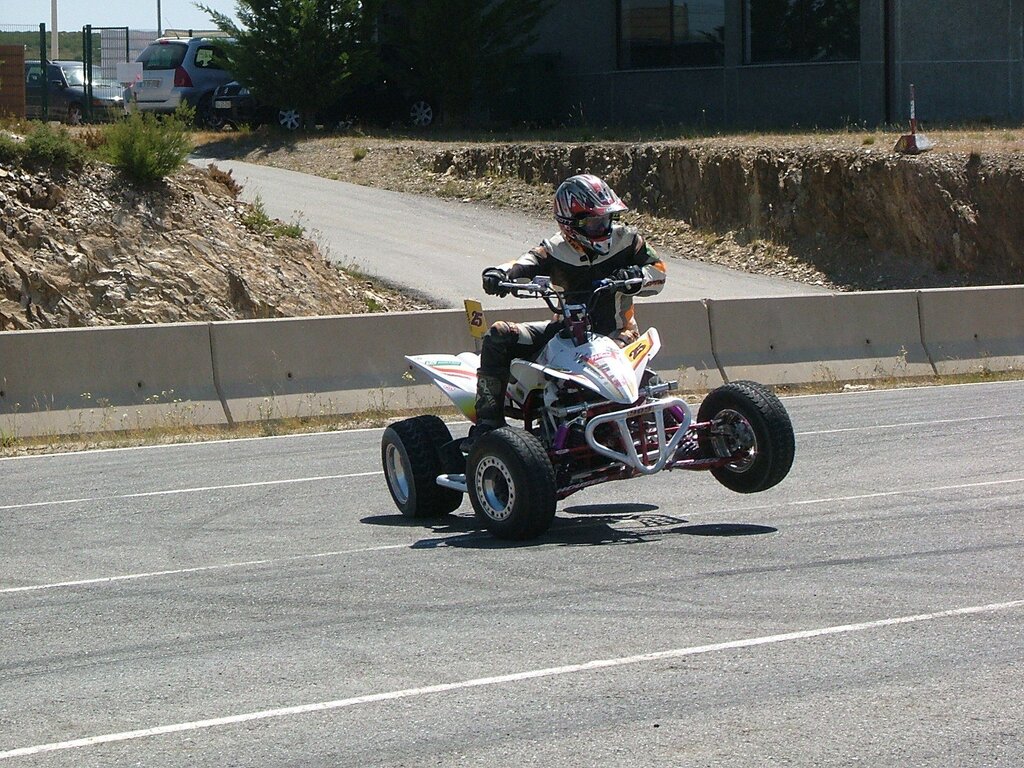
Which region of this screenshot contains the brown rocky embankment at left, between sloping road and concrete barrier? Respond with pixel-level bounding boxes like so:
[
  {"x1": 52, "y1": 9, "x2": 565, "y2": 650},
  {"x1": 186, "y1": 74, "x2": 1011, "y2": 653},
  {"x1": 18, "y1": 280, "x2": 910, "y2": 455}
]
[{"x1": 0, "y1": 163, "x2": 424, "y2": 331}]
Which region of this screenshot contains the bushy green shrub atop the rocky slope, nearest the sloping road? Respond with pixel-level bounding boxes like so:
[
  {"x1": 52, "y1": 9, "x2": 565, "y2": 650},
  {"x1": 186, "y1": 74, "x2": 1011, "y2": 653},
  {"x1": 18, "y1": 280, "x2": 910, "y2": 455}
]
[{"x1": 102, "y1": 109, "x2": 194, "y2": 183}]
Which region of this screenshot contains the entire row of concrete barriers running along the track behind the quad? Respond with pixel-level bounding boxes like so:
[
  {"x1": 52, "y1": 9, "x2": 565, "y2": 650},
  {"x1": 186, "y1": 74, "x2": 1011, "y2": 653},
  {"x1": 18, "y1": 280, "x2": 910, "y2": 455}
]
[{"x1": 0, "y1": 286, "x2": 1024, "y2": 436}]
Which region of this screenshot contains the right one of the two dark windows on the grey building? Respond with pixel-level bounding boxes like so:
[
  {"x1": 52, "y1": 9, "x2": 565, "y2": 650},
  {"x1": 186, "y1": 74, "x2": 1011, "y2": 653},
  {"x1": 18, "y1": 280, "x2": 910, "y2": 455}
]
[{"x1": 743, "y1": 0, "x2": 860, "y2": 63}]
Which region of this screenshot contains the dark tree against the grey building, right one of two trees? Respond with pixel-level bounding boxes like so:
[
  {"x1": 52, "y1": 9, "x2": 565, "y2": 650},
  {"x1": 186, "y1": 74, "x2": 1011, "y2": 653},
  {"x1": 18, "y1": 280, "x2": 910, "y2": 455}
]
[{"x1": 382, "y1": 0, "x2": 551, "y2": 123}]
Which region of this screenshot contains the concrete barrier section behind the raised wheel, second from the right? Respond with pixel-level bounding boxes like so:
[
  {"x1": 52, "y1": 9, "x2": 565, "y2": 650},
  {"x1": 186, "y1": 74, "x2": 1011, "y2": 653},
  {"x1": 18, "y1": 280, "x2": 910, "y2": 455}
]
[{"x1": 709, "y1": 291, "x2": 934, "y2": 384}]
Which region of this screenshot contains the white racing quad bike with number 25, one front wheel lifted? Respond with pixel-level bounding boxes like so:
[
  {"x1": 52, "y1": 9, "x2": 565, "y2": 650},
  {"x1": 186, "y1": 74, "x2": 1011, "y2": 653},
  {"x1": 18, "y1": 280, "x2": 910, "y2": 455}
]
[{"x1": 381, "y1": 276, "x2": 796, "y2": 540}]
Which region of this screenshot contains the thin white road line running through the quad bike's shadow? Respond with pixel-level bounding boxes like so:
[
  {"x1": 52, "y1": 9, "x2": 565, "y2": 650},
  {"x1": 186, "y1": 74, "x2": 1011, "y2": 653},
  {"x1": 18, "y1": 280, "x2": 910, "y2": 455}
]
[{"x1": 0, "y1": 472, "x2": 1024, "y2": 595}]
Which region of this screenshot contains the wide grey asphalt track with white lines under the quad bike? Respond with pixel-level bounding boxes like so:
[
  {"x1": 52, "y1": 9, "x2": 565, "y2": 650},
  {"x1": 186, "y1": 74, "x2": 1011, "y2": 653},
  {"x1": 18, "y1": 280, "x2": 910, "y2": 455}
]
[{"x1": 0, "y1": 382, "x2": 1024, "y2": 768}]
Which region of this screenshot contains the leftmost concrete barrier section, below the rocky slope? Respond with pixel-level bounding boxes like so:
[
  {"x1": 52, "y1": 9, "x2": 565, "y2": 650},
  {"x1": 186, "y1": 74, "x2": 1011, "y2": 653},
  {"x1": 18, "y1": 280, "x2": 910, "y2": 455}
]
[{"x1": 0, "y1": 323, "x2": 224, "y2": 436}]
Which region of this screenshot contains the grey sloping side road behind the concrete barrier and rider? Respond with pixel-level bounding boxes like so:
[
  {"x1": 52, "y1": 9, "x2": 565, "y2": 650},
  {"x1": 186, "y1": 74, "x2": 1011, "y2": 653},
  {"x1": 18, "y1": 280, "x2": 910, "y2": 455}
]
[{"x1": 194, "y1": 160, "x2": 824, "y2": 309}]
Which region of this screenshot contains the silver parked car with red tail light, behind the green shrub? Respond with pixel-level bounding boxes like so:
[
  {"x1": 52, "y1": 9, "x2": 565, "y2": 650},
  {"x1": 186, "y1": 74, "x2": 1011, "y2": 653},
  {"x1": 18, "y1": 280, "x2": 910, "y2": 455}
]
[{"x1": 132, "y1": 37, "x2": 233, "y2": 128}]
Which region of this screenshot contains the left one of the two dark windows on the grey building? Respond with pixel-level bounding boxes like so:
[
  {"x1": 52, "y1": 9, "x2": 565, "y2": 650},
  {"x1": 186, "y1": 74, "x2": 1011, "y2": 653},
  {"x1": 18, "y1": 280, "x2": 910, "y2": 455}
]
[{"x1": 618, "y1": 0, "x2": 725, "y2": 70}]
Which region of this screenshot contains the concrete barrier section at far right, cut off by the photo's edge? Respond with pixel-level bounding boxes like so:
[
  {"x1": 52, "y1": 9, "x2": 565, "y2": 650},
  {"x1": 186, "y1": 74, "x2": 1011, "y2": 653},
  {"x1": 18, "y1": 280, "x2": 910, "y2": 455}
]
[{"x1": 920, "y1": 286, "x2": 1024, "y2": 374}]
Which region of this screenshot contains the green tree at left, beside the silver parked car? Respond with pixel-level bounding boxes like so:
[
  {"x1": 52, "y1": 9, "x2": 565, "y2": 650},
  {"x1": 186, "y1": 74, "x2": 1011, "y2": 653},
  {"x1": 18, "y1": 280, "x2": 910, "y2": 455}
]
[{"x1": 196, "y1": 0, "x2": 369, "y2": 123}]
